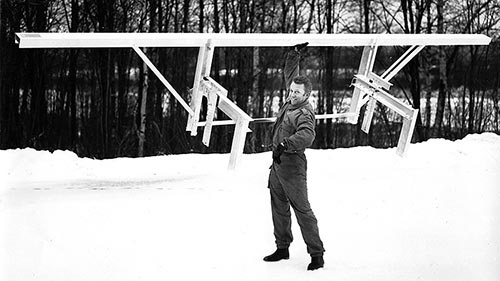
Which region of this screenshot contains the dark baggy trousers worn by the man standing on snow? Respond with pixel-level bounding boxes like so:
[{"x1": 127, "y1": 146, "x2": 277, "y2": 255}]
[{"x1": 269, "y1": 153, "x2": 325, "y2": 256}]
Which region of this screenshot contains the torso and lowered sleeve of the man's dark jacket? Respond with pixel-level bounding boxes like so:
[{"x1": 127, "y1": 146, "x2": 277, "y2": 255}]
[{"x1": 273, "y1": 100, "x2": 316, "y2": 153}]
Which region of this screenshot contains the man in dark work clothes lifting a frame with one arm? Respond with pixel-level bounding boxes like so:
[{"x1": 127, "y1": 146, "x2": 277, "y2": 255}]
[{"x1": 264, "y1": 43, "x2": 325, "y2": 270}]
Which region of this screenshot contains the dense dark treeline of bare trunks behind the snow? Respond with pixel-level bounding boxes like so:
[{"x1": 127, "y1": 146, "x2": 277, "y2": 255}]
[{"x1": 0, "y1": 0, "x2": 500, "y2": 158}]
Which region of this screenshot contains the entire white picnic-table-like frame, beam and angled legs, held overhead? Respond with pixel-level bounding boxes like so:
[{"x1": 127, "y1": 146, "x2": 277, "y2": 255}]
[{"x1": 16, "y1": 33, "x2": 491, "y2": 169}]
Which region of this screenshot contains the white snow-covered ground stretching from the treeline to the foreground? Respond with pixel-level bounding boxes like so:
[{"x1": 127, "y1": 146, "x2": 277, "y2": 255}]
[{"x1": 0, "y1": 133, "x2": 500, "y2": 281}]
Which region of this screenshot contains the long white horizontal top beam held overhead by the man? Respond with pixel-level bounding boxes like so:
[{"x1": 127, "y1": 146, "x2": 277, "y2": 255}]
[{"x1": 16, "y1": 33, "x2": 491, "y2": 48}]
